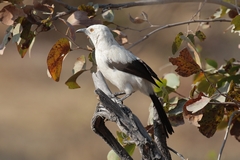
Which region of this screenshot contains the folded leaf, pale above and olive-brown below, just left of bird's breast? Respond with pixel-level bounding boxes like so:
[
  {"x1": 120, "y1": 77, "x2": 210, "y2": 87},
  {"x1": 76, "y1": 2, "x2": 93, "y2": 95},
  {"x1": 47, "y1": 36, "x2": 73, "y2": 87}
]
[{"x1": 65, "y1": 55, "x2": 87, "y2": 89}]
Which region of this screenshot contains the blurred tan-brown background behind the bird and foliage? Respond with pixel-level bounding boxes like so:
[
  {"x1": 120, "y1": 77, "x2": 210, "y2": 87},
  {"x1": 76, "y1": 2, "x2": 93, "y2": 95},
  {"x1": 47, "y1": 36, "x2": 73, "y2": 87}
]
[{"x1": 0, "y1": 0, "x2": 240, "y2": 160}]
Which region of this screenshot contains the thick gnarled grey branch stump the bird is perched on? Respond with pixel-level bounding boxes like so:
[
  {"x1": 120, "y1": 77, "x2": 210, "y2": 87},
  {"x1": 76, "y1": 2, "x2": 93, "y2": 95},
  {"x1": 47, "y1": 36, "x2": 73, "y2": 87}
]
[{"x1": 92, "y1": 71, "x2": 171, "y2": 160}]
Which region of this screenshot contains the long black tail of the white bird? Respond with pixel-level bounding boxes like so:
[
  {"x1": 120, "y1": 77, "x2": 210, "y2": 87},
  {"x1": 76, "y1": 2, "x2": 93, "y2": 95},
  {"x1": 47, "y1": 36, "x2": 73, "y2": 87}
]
[{"x1": 149, "y1": 94, "x2": 174, "y2": 137}]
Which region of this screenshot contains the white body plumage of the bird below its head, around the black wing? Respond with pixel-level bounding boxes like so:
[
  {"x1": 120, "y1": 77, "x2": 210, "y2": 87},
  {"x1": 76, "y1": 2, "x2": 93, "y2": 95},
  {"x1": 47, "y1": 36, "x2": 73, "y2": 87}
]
[{"x1": 95, "y1": 45, "x2": 152, "y2": 94}]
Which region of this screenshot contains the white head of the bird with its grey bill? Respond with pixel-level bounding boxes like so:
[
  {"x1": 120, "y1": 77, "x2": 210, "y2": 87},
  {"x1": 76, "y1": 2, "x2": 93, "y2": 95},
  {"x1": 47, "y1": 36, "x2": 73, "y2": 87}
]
[{"x1": 76, "y1": 24, "x2": 115, "y2": 47}]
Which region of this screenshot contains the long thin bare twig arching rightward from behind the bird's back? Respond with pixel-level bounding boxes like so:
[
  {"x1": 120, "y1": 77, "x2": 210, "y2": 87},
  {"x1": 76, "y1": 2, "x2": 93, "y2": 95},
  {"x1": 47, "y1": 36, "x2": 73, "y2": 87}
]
[{"x1": 128, "y1": 19, "x2": 231, "y2": 49}]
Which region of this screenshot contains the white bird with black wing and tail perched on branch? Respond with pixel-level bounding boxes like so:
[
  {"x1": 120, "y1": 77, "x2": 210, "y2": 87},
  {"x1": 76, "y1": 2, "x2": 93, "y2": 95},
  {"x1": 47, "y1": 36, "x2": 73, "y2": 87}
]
[{"x1": 76, "y1": 24, "x2": 174, "y2": 137}]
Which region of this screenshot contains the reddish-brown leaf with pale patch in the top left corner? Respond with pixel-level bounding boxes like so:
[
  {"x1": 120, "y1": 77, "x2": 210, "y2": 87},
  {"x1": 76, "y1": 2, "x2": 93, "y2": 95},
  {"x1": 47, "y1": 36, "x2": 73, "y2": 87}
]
[{"x1": 0, "y1": 4, "x2": 25, "y2": 25}]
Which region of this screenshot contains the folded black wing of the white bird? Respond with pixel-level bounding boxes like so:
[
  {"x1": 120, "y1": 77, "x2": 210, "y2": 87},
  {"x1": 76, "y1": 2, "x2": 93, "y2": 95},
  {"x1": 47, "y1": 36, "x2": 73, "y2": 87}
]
[{"x1": 108, "y1": 59, "x2": 160, "y2": 86}]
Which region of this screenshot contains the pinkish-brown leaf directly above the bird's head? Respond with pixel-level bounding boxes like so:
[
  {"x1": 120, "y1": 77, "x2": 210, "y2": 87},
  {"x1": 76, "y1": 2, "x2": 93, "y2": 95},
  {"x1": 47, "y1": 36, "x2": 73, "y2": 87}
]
[{"x1": 67, "y1": 11, "x2": 101, "y2": 27}]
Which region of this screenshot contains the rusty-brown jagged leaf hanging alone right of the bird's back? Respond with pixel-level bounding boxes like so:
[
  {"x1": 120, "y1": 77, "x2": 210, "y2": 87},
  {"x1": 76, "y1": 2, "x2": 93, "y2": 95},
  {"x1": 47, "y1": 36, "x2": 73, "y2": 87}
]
[{"x1": 169, "y1": 48, "x2": 201, "y2": 77}]
